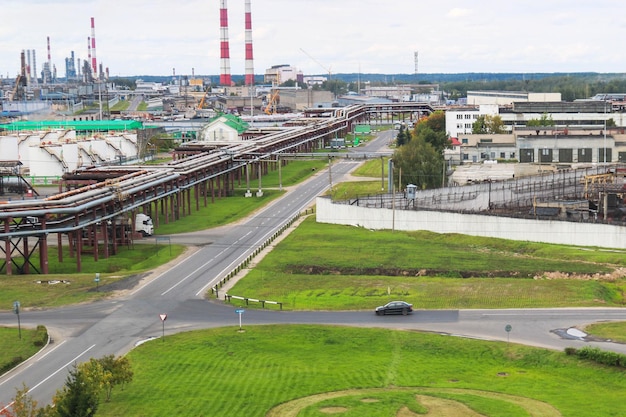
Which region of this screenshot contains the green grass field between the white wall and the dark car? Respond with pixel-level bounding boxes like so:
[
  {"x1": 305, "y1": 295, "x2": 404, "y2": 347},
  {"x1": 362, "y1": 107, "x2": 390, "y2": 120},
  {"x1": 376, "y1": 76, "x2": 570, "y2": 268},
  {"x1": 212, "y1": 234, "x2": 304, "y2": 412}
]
[{"x1": 228, "y1": 217, "x2": 626, "y2": 310}]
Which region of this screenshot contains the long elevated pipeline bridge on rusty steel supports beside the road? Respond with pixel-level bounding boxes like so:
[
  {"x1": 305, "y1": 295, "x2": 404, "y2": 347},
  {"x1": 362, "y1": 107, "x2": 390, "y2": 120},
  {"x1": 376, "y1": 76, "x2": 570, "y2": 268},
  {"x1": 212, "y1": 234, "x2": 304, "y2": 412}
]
[{"x1": 0, "y1": 103, "x2": 434, "y2": 275}]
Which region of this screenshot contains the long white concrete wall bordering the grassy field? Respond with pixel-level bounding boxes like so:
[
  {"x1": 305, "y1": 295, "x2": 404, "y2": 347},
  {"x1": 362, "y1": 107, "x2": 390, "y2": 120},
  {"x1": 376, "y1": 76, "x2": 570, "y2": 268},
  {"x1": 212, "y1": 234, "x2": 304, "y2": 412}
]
[{"x1": 316, "y1": 197, "x2": 626, "y2": 249}]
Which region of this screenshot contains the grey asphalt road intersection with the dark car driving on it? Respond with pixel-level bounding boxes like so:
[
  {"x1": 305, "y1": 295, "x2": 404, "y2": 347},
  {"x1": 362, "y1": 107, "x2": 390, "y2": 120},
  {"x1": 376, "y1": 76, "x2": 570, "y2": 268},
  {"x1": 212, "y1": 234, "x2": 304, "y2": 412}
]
[{"x1": 0, "y1": 132, "x2": 626, "y2": 404}]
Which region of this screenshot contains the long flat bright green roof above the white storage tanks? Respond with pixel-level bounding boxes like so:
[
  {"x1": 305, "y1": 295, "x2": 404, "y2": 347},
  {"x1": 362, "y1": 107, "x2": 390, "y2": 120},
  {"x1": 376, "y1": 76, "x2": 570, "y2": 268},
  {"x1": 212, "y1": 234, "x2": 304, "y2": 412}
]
[{"x1": 0, "y1": 120, "x2": 143, "y2": 132}]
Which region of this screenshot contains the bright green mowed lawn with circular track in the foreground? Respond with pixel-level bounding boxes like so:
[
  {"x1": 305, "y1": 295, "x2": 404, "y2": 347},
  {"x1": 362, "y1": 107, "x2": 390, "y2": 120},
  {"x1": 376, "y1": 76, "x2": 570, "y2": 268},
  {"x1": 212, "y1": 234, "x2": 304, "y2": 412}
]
[{"x1": 98, "y1": 324, "x2": 626, "y2": 417}]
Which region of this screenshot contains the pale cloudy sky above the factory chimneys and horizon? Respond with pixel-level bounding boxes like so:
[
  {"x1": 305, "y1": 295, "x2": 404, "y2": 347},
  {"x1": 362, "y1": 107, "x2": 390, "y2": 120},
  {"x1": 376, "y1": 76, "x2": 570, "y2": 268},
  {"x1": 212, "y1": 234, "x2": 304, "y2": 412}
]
[{"x1": 0, "y1": 0, "x2": 626, "y2": 77}]
